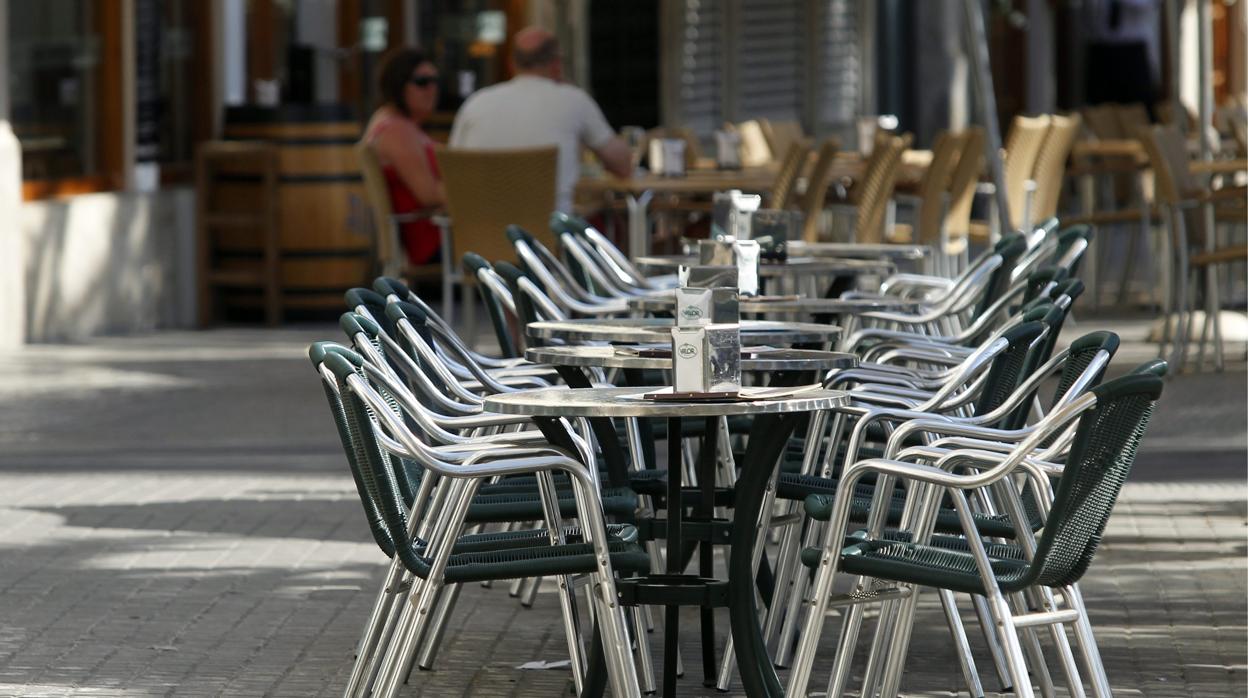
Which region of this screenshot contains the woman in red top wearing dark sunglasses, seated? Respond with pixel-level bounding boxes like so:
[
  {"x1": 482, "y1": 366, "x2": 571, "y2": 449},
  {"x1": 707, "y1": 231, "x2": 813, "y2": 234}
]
[{"x1": 364, "y1": 49, "x2": 446, "y2": 265}]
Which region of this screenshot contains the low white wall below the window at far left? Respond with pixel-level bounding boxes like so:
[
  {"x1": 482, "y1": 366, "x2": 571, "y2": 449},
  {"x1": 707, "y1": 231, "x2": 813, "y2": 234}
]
[{"x1": 20, "y1": 187, "x2": 195, "y2": 342}]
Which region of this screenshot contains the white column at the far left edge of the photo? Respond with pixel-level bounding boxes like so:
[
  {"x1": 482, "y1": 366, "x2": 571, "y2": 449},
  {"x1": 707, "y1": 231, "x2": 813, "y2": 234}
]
[{"x1": 0, "y1": 0, "x2": 26, "y2": 350}]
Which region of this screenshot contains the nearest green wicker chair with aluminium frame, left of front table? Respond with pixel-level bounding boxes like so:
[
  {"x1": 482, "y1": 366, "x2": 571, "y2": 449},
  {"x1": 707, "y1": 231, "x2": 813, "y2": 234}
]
[{"x1": 310, "y1": 343, "x2": 649, "y2": 696}]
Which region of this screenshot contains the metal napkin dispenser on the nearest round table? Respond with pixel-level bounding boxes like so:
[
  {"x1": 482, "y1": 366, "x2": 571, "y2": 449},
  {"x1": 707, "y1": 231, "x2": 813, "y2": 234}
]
[{"x1": 671, "y1": 323, "x2": 741, "y2": 393}]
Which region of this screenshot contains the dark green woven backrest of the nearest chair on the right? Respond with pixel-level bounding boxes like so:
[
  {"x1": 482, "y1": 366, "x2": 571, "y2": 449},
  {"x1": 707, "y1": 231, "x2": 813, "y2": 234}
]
[{"x1": 1020, "y1": 373, "x2": 1163, "y2": 587}]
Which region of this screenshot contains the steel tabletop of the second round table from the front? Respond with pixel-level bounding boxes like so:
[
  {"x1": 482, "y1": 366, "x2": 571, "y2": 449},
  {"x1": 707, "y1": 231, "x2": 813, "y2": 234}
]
[{"x1": 524, "y1": 346, "x2": 857, "y2": 372}]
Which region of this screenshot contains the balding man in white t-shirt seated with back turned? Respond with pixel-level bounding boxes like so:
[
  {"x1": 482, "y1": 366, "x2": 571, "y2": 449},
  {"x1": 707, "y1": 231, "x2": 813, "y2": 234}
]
[{"x1": 451, "y1": 26, "x2": 631, "y2": 212}]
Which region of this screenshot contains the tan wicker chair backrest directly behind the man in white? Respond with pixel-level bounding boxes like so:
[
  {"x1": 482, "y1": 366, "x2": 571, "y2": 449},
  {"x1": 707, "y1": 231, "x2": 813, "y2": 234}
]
[{"x1": 438, "y1": 146, "x2": 558, "y2": 264}]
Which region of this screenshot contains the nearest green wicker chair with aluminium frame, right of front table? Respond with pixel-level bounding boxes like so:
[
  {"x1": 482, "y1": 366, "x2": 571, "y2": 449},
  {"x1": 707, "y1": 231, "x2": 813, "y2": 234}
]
[{"x1": 787, "y1": 372, "x2": 1162, "y2": 697}]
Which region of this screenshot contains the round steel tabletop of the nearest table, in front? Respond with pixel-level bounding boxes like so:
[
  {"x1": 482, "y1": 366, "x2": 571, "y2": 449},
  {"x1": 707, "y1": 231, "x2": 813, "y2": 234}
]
[{"x1": 484, "y1": 387, "x2": 849, "y2": 418}]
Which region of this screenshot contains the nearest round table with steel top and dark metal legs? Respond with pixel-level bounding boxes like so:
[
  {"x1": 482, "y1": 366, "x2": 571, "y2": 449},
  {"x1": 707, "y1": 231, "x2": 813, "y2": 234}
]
[{"x1": 484, "y1": 387, "x2": 849, "y2": 696}]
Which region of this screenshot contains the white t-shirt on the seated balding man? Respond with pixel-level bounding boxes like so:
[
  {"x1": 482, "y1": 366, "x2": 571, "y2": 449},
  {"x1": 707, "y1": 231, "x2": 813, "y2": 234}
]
[{"x1": 451, "y1": 75, "x2": 615, "y2": 212}]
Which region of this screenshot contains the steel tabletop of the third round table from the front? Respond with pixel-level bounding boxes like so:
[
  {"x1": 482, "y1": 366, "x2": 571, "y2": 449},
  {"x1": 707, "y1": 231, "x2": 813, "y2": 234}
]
[{"x1": 524, "y1": 317, "x2": 841, "y2": 345}]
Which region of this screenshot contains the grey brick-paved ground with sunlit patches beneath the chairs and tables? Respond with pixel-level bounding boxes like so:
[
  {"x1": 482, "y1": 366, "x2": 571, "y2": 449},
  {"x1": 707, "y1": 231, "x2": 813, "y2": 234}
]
[{"x1": 0, "y1": 326, "x2": 1248, "y2": 697}]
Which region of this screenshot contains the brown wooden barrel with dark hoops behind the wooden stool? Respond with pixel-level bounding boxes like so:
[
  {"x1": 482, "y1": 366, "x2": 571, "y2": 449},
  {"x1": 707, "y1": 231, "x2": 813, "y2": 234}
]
[{"x1": 210, "y1": 105, "x2": 374, "y2": 310}]
